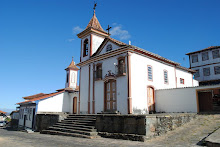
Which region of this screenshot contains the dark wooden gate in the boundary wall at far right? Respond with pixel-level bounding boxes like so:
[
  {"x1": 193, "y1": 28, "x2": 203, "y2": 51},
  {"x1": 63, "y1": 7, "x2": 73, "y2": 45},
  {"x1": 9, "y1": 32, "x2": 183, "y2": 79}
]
[{"x1": 198, "y1": 92, "x2": 212, "y2": 112}]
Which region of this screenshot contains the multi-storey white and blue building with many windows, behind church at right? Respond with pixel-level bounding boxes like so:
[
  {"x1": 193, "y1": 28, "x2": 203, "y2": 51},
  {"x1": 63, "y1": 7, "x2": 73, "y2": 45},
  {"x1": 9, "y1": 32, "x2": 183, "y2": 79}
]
[{"x1": 186, "y1": 46, "x2": 220, "y2": 85}]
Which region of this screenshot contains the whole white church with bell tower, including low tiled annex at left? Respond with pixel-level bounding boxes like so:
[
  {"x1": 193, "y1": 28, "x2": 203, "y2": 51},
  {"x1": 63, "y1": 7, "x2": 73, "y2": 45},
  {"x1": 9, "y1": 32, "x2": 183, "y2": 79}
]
[{"x1": 17, "y1": 7, "x2": 198, "y2": 129}]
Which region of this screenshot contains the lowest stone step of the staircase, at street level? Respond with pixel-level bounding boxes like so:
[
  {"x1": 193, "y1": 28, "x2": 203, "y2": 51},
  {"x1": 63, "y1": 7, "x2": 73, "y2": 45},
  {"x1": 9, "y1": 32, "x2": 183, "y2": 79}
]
[{"x1": 41, "y1": 130, "x2": 98, "y2": 139}]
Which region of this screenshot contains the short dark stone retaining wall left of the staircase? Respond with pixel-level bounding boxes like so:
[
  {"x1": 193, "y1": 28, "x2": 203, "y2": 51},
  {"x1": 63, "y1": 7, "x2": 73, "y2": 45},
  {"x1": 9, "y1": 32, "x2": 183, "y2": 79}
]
[{"x1": 35, "y1": 113, "x2": 68, "y2": 131}]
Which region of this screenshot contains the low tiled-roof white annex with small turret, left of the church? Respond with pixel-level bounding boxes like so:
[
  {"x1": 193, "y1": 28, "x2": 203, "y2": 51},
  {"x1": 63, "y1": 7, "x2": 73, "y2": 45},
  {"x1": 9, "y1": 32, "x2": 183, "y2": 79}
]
[{"x1": 17, "y1": 60, "x2": 79, "y2": 130}]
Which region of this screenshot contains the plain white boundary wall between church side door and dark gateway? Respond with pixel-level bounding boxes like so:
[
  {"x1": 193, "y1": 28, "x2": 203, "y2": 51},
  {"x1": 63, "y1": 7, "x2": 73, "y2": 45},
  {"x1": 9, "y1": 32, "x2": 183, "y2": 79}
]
[{"x1": 155, "y1": 85, "x2": 220, "y2": 113}]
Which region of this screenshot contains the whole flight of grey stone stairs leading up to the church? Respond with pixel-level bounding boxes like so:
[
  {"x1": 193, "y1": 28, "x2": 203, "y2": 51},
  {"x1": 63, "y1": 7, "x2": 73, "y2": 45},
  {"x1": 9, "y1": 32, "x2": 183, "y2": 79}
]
[{"x1": 41, "y1": 114, "x2": 98, "y2": 139}]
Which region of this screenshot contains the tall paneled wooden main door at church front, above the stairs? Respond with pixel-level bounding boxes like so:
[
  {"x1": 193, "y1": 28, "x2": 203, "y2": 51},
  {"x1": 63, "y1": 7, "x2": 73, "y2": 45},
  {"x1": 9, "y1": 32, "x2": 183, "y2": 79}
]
[{"x1": 105, "y1": 80, "x2": 117, "y2": 112}]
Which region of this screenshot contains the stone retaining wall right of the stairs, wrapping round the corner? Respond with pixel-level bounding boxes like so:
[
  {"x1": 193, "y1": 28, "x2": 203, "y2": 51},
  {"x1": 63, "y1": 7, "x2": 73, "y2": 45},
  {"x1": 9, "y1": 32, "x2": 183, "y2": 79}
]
[{"x1": 95, "y1": 113, "x2": 196, "y2": 141}]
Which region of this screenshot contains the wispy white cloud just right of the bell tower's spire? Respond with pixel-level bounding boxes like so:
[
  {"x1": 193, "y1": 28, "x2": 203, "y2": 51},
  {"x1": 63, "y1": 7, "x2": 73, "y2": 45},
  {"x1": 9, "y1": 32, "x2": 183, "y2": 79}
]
[{"x1": 110, "y1": 23, "x2": 131, "y2": 40}]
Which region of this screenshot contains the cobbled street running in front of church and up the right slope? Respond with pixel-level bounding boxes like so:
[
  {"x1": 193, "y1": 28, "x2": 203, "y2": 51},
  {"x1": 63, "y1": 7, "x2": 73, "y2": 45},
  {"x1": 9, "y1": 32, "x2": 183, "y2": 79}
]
[{"x1": 0, "y1": 115, "x2": 220, "y2": 147}]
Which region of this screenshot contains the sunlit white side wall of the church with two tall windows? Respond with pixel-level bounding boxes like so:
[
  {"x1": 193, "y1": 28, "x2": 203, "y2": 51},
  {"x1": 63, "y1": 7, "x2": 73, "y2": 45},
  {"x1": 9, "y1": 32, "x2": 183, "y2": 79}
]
[{"x1": 131, "y1": 53, "x2": 196, "y2": 114}]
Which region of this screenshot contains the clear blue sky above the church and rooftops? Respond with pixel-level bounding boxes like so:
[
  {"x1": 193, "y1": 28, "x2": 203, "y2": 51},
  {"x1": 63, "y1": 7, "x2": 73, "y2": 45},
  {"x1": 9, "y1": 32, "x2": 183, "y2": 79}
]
[{"x1": 0, "y1": 0, "x2": 220, "y2": 110}]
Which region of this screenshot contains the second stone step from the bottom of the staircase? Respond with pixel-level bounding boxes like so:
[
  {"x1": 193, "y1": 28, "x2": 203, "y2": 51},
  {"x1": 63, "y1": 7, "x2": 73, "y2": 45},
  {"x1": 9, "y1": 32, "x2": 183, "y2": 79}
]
[{"x1": 48, "y1": 127, "x2": 98, "y2": 136}]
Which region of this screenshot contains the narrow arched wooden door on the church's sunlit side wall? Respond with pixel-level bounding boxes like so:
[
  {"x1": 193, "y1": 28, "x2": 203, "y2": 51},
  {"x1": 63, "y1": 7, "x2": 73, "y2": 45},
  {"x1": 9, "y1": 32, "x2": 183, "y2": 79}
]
[{"x1": 147, "y1": 87, "x2": 155, "y2": 112}]
